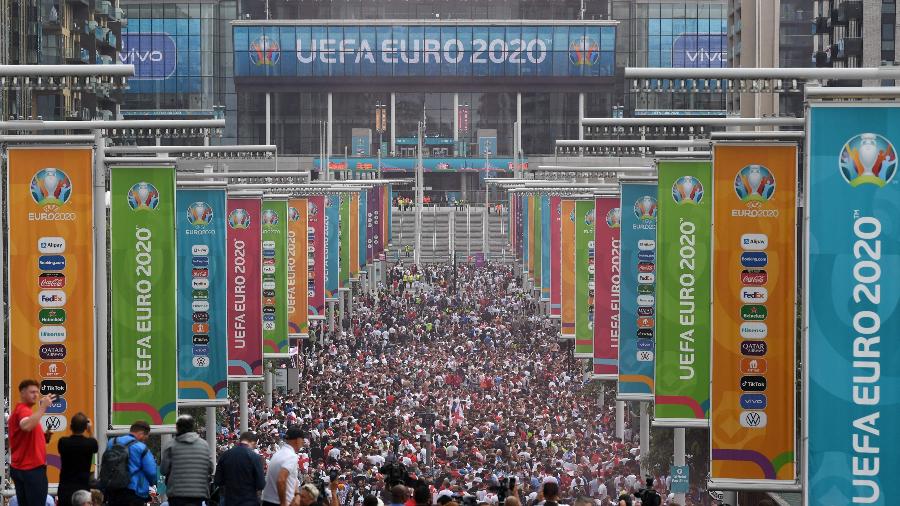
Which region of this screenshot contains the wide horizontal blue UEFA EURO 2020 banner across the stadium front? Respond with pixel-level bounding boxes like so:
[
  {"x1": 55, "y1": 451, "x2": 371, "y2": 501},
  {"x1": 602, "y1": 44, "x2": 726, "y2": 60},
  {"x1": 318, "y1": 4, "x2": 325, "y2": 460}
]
[{"x1": 233, "y1": 21, "x2": 616, "y2": 78}]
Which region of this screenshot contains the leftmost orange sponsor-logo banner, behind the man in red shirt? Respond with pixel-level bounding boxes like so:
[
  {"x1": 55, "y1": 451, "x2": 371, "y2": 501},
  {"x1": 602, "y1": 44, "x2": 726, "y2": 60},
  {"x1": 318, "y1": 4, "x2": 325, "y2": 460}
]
[{"x1": 4, "y1": 147, "x2": 95, "y2": 483}]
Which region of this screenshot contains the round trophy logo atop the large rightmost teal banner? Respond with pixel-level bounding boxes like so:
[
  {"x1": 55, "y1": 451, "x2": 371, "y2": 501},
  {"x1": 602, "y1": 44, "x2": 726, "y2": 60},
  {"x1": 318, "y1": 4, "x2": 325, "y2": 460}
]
[{"x1": 839, "y1": 133, "x2": 897, "y2": 188}]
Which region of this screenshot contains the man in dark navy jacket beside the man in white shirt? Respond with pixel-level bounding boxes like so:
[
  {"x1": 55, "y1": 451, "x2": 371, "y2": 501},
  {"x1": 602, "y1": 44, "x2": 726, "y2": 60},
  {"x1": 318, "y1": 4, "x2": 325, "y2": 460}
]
[{"x1": 214, "y1": 431, "x2": 266, "y2": 506}]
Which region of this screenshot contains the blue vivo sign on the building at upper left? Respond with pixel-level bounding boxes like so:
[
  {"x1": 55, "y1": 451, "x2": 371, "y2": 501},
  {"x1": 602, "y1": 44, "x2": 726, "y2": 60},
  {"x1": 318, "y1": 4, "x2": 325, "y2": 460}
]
[{"x1": 119, "y1": 33, "x2": 178, "y2": 80}]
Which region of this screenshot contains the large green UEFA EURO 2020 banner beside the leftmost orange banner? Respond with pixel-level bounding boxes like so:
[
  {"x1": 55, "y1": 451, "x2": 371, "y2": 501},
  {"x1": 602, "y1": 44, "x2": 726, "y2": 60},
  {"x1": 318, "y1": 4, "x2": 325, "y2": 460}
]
[{"x1": 109, "y1": 167, "x2": 178, "y2": 427}]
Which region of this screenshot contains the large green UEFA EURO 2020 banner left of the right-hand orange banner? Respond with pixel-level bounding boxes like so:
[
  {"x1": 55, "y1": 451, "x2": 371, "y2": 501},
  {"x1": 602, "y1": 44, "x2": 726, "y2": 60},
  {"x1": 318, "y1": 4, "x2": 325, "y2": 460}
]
[{"x1": 654, "y1": 160, "x2": 713, "y2": 427}]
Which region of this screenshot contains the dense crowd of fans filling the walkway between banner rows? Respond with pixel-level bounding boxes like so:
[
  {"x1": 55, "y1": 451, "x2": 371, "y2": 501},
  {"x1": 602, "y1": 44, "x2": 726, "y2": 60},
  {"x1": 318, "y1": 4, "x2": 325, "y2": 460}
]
[{"x1": 220, "y1": 264, "x2": 702, "y2": 506}]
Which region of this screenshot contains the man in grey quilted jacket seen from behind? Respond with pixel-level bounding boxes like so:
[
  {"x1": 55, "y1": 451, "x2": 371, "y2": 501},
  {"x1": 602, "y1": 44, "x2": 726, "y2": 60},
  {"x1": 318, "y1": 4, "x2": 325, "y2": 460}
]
[{"x1": 160, "y1": 415, "x2": 212, "y2": 506}]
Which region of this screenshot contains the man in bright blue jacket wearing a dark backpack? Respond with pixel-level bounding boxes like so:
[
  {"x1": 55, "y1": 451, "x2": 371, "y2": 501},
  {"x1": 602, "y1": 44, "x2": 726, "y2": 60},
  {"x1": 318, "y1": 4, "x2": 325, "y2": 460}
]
[{"x1": 99, "y1": 420, "x2": 156, "y2": 506}]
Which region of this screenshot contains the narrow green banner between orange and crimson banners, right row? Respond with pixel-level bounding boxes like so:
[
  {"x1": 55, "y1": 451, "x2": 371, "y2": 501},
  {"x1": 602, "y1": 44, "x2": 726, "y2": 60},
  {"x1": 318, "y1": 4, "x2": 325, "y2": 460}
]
[{"x1": 575, "y1": 200, "x2": 595, "y2": 359}]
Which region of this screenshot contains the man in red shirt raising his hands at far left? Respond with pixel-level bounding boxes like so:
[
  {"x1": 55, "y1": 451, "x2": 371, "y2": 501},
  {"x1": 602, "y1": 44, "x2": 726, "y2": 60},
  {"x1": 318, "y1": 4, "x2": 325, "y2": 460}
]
[{"x1": 8, "y1": 379, "x2": 56, "y2": 506}]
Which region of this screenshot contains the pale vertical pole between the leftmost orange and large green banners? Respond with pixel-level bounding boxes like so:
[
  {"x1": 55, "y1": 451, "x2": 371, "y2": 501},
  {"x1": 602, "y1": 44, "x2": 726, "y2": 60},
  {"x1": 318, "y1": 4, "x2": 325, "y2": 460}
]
[{"x1": 94, "y1": 130, "x2": 109, "y2": 454}]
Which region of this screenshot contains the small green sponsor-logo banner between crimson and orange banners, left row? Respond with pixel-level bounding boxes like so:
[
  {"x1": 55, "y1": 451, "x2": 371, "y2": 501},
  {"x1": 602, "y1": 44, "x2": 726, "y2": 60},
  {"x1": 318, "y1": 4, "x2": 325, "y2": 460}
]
[{"x1": 262, "y1": 199, "x2": 290, "y2": 358}]
